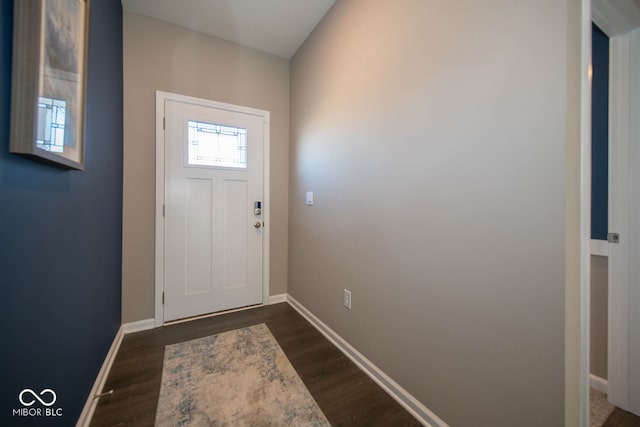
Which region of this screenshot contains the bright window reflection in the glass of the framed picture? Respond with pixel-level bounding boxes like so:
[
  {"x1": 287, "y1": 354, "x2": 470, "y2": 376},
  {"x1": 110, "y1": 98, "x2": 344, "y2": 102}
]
[{"x1": 36, "y1": 96, "x2": 67, "y2": 153}]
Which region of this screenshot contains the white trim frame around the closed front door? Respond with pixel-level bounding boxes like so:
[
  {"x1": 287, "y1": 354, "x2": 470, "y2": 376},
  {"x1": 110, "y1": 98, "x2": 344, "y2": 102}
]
[{"x1": 154, "y1": 90, "x2": 271, "y2": 327}]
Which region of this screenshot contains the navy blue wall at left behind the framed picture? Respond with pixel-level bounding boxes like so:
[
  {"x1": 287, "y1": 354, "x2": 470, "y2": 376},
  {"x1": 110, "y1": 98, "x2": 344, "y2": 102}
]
[{"x1": 0, "y1": 0, "x2": 122, "y2": 426}]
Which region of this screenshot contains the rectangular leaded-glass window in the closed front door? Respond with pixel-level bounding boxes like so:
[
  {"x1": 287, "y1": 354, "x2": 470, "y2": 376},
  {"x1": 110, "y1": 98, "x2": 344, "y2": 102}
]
[{"x1": 188, "y1": 120, "x2": 247, "y2": 168}]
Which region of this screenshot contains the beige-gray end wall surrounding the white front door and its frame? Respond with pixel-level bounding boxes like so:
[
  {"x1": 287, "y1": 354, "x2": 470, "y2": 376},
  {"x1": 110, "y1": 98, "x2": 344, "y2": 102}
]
[{"x1": 122, "y1": 12, "x2": 289, "y2": 322}]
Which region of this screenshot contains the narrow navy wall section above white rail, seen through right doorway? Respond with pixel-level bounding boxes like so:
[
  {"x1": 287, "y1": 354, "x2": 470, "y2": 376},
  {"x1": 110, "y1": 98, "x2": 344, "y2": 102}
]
[{"x1": 591, "y1": 25, "x2": 609, "y2": 240}]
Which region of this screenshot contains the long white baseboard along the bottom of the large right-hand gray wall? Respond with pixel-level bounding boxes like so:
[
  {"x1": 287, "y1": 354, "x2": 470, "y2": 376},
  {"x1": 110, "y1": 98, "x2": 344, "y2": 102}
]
[{"x1": 287, "y1": 295, "x2": 448, "y2": 427}]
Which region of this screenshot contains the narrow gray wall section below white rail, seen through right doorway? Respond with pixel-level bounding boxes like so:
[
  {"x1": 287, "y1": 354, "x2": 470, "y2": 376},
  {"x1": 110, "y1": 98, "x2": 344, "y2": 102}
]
[{"x1": 589, "y1": 255, "x2": 609, "y2": 379}]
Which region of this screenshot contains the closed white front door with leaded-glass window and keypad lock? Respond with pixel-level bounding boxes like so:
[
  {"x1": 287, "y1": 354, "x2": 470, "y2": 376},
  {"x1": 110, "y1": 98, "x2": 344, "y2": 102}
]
[{"x1": 164, "y1": 100, "x2": 264, "y2": 322}]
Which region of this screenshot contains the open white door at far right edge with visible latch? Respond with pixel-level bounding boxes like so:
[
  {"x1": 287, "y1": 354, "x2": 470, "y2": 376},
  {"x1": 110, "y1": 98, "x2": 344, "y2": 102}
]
[{"x1": 607, "y1": 29, "x2": 640, "y2": 415}]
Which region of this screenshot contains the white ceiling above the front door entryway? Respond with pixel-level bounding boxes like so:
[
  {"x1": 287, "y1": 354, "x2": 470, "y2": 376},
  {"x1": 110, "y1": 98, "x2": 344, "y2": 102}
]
[{"x1": 122, "y1": 0, "x2": 335, "y2": 59}]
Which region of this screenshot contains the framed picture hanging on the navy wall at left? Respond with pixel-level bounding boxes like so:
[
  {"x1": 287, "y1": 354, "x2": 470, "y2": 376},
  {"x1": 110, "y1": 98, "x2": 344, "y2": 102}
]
[{"x1": 10, "y1": 0, "x2": 89, "y2": 170}]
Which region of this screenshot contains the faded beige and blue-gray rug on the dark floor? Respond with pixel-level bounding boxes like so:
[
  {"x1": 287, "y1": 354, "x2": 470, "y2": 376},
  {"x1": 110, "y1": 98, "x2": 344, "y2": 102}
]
[{"x1": 156, "y1": 324, "x2": 330, "y2": 426}]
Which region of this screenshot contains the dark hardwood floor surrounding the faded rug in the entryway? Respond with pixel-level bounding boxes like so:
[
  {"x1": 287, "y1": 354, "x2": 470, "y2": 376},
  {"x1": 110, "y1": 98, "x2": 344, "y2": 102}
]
[{"x1": 91, "y1": 303, "x2": 420, "y2": 427}]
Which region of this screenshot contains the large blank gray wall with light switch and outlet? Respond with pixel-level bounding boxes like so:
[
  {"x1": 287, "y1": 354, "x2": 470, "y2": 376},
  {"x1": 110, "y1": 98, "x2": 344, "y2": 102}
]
[{"x1": 289, "y1": 0, "x2": 580, "y2": 427}]
